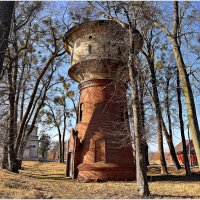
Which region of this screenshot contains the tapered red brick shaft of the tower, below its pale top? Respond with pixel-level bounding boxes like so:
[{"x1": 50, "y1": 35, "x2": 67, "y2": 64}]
[{"x1": 67, "y1": 80, "x2": 135, "y2": 180}]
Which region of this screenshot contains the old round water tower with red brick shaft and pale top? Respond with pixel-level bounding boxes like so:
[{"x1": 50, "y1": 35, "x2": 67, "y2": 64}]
[{"x1": 64, "y1": 20, "x2": 142, "y2": 181}]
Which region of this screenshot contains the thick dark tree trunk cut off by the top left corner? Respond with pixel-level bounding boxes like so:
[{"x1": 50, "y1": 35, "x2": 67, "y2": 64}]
[{"x1": 0, "y1": 1, "x2": 15, "y2": 75}]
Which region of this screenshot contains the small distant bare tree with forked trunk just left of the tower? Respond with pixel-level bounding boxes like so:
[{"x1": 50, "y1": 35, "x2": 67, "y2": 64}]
[{"x1": 42, "y1": 80, "x2": 74, "y2": 163}]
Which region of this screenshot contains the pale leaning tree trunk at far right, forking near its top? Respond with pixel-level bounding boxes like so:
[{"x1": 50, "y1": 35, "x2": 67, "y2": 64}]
[{"x1": 153, "y1": 1, "x2": 200, "y2": 167}]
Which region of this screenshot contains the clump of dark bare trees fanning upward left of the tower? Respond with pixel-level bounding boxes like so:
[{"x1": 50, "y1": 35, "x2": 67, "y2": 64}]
[{"x1": 1, "y1": 2, "x2": 65, "y2": 172}]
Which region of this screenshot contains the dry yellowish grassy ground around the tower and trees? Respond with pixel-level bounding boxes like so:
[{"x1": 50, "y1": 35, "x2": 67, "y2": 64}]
[{"x1": 0, "y1": 161, "x2": 200, "y2": 199}]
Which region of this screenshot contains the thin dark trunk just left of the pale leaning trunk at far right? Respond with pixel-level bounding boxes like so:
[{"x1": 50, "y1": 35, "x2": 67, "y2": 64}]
[{"x1": 177, "y1": 71, "x2": 191, "y2": 175}]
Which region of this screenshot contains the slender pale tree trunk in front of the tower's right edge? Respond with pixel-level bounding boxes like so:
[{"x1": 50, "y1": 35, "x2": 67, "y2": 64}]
[{"x1": 128, "y1": 27, "x2": 149, "y2": 197}]
